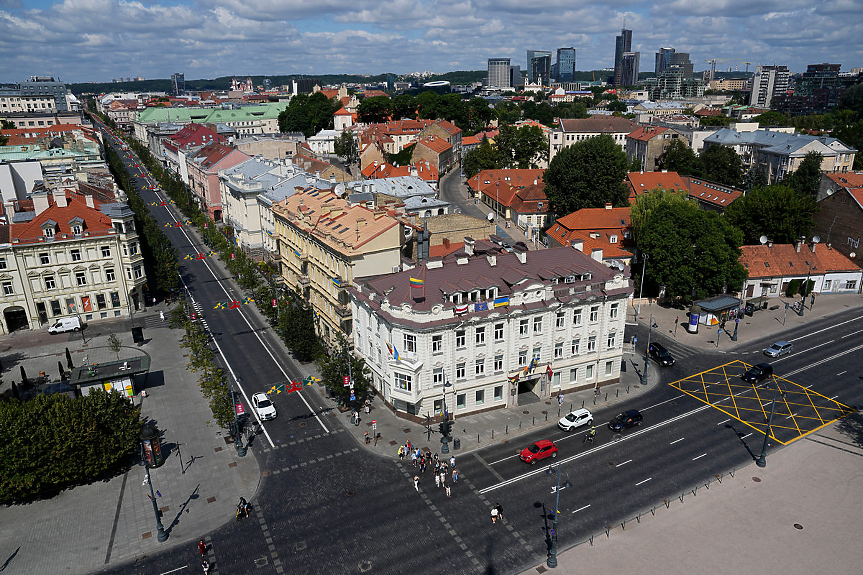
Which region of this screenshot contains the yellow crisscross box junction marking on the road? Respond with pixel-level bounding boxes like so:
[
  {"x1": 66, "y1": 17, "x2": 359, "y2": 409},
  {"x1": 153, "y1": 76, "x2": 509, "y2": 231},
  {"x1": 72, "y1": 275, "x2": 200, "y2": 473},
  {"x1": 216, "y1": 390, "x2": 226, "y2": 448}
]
[{"x1": 669, "y1": 360, "x2": 854, "y2": 445}]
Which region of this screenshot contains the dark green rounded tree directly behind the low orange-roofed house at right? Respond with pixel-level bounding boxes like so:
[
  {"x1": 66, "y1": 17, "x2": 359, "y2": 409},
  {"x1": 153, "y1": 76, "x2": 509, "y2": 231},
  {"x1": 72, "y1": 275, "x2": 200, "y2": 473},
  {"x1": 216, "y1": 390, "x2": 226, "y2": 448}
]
[{"x1": 725, "y1": 184, "x2": 817, "y2": 245}]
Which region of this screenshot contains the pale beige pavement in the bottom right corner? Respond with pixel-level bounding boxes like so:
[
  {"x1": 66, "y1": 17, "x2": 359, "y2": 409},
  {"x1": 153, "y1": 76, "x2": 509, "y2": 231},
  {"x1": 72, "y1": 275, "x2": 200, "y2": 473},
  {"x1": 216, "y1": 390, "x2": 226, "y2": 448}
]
[{"x1": 524, "y1": 413, "x2": 863, "y2": 575}]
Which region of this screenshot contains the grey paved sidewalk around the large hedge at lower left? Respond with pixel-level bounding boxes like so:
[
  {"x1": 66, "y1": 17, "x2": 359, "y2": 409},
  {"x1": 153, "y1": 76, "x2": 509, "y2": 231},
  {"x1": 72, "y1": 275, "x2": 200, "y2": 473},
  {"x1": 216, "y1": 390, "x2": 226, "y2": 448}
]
[{"x1": 0, "y1": 310, "x2": 260, "y2": 575}]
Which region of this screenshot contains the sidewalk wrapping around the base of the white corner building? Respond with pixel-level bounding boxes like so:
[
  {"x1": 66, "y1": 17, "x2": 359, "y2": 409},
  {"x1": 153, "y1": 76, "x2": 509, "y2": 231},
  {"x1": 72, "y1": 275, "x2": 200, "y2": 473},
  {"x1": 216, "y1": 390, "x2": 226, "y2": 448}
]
[{"x1": 338, "y1": 353, "x2": 659, "y2": 458}]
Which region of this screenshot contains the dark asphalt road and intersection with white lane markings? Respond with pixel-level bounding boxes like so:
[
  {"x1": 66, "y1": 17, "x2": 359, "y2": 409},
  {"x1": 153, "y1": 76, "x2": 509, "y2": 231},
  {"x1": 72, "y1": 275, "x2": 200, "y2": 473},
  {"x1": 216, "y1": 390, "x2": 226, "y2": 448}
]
[{"x1": 94, "y1": 121, "x2": 863, "y2": 574}]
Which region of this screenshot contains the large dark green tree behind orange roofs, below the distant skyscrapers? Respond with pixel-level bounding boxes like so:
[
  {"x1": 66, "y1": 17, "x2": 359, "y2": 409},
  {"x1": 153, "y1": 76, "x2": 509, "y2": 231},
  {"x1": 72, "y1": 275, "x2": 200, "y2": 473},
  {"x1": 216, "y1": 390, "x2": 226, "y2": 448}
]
[{"x1": 545, "y1": 135, "x2": 629, "y2": 215}]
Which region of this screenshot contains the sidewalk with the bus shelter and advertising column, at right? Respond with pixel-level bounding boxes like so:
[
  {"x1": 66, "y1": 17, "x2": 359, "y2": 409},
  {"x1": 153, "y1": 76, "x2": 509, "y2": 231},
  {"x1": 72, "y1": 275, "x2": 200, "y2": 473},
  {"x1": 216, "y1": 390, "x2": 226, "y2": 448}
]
[{"x1": 627, "y1": 294, "x2": 863, "y2": 353}]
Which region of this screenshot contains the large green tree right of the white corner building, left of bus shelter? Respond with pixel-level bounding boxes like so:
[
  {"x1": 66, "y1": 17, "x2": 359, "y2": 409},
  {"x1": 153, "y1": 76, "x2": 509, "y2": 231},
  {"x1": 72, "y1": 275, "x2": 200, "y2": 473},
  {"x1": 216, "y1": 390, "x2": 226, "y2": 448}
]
[{"x1": 633, "y1": 194, "x2": 746, "y2": 300}]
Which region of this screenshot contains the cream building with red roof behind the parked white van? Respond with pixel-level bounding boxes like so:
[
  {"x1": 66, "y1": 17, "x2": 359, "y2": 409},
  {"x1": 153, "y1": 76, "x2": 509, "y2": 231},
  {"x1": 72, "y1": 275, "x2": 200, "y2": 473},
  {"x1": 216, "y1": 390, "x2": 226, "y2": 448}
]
[{"x1": 0, "y1": 190, "x2": 147, "y2": 333}]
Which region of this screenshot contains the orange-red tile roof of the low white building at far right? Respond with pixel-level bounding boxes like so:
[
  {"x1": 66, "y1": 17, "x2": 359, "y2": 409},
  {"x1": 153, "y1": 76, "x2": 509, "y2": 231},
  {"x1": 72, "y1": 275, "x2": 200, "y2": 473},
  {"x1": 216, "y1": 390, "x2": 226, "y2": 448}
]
[{"x1": 740, "y1": 244, "x2": 860, "y2": 279}]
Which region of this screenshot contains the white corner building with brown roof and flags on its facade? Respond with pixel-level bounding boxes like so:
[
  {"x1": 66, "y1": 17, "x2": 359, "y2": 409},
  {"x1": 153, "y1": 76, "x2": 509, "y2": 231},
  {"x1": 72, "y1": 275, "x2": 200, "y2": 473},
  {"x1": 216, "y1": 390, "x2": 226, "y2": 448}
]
[{"x1": 349, "y1": 238, "x2": 633, "y2": 421}]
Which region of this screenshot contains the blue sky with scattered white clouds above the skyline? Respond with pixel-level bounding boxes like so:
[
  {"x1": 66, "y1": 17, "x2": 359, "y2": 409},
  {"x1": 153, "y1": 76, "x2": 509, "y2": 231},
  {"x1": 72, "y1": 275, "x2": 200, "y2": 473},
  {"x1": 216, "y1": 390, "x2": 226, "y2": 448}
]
[{"x1": 0, "y1": 0, "x2": 863, "y2": 83}]
